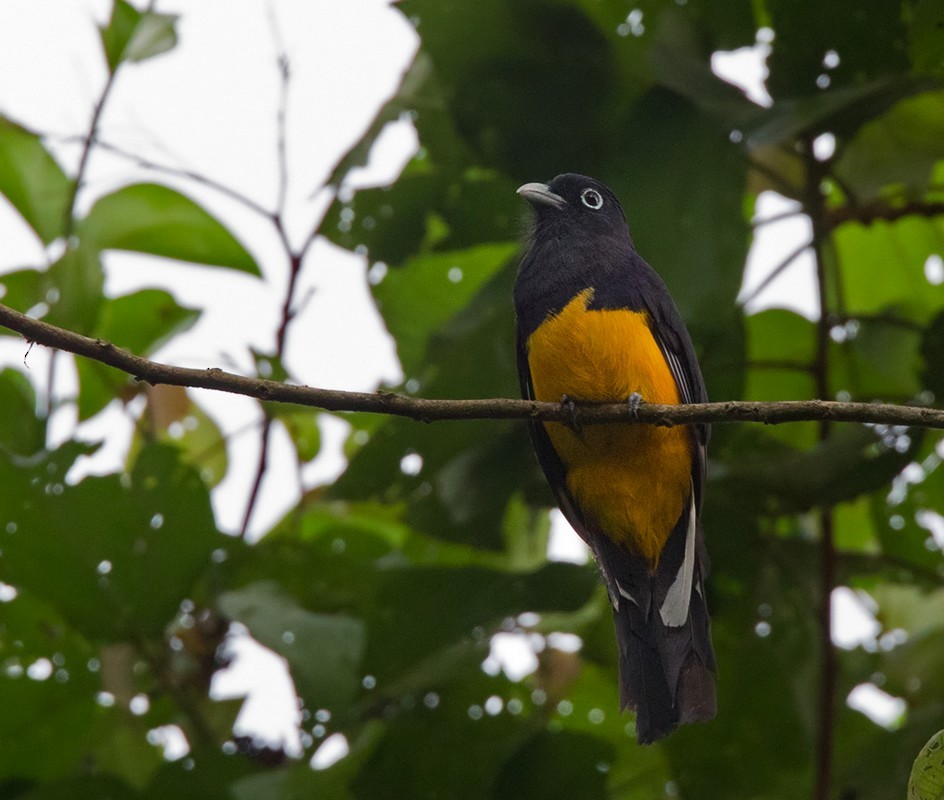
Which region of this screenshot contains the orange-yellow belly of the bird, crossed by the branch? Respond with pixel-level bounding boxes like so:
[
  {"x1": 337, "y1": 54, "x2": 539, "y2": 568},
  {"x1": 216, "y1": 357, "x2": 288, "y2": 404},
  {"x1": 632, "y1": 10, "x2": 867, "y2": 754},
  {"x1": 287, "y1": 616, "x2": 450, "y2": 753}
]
[{"x1": 528, "y1": 289, "x2": 692, "y2": 568}]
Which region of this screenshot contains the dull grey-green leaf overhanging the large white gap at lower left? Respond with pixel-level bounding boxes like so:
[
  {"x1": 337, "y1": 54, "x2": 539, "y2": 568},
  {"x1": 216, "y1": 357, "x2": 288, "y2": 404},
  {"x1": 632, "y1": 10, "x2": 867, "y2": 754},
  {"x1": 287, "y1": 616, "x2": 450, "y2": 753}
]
[{"x1": 217, "y1": 583, "x2": 366, "y2": 712}]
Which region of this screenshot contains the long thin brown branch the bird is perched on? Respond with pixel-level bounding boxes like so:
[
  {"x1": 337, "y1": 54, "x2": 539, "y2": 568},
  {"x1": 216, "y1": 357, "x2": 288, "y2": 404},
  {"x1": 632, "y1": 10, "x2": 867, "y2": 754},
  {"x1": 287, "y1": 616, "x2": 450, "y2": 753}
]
[{"x1": 0, "y1": 304, "x2": 944, "y2": 429}]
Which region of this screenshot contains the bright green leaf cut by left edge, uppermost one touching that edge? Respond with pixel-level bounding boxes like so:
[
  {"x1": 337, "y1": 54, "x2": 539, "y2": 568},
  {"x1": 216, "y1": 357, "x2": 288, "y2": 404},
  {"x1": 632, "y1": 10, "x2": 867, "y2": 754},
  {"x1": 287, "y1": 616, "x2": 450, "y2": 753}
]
[{"x1": 0, "y1": 115, "x2": 71, "y2": 244}]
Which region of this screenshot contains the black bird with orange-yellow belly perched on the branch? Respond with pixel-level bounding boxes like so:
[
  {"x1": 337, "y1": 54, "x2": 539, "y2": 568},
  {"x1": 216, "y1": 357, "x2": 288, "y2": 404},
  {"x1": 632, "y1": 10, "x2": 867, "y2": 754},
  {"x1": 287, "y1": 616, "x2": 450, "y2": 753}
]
[{"x1": 514, "y1": 173, "x2": 717, "y2": 744}]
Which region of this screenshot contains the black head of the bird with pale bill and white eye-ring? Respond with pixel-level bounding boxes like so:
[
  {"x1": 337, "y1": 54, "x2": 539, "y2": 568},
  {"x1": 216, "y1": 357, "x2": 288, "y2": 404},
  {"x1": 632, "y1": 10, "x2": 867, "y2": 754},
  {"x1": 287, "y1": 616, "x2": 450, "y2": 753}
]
[{"x1": 518, "y1": 172, "x2": 628, "y2": 241}]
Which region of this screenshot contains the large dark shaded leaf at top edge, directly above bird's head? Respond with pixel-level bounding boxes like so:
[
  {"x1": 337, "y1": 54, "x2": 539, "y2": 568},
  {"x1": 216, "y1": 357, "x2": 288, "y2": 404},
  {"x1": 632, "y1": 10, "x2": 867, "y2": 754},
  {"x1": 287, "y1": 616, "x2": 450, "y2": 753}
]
[{"x1": 399, "y1": 0, "x2": 624, "y2": 183}]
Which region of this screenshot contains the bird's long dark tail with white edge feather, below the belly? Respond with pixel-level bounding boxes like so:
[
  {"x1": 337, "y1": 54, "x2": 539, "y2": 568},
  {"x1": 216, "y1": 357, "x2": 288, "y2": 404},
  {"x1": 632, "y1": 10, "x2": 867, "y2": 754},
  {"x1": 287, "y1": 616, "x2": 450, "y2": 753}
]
[{"x1": 594, "y1": 496, "x2": 716, "y2": 744}]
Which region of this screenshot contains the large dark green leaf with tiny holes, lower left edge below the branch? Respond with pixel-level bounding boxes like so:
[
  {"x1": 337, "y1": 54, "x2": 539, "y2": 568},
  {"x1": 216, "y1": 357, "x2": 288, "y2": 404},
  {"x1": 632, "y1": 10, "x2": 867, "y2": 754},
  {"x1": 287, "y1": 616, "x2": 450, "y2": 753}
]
[{"x1": 0, "y1": 445, "x2": 221, "y2": 640}]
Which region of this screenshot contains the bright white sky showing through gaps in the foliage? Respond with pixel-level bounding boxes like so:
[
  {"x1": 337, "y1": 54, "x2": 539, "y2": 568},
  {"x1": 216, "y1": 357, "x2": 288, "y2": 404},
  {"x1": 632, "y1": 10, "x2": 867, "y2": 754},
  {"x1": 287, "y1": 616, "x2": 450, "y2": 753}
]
[{"x1": 0, "y1": 0, "x2": 896, "y2": 763}]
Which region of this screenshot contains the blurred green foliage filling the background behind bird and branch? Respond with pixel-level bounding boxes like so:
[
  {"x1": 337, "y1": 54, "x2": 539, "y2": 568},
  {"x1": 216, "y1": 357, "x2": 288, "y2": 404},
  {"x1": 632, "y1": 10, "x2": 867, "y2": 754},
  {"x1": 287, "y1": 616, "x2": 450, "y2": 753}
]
[{"x1": 0, "y1": 0, "x2": 944, "y2": 800}]
